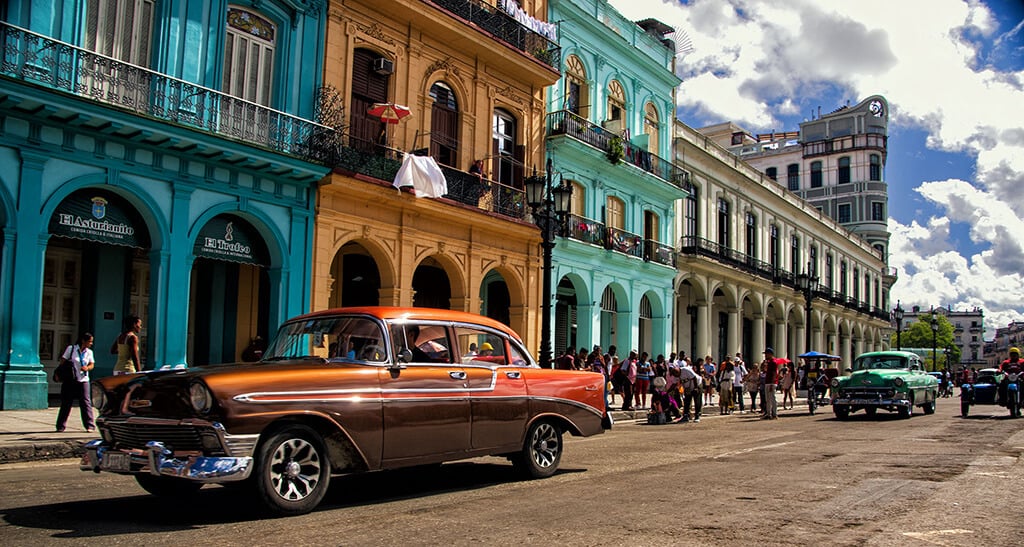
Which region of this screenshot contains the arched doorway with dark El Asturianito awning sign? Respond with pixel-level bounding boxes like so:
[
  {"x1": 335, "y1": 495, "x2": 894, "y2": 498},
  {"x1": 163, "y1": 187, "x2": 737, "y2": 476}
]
[{"x1": 39, "y1": 188, "x2": 151, "y2": 385}]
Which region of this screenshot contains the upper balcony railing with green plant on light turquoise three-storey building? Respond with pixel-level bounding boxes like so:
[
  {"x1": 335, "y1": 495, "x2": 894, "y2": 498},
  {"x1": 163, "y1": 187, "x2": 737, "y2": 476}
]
[{"x1": 547, "y1": 111, "x2": 689, "y2": 188}]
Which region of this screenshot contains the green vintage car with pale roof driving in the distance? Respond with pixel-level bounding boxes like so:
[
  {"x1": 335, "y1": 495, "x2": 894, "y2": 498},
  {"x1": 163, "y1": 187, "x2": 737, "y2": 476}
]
[{"x1": 831, "y1": 351, "x2": 939, "y2": 420}]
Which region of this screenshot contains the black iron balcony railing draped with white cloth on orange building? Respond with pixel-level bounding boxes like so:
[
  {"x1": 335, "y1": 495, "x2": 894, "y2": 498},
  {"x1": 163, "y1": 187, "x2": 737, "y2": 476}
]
[{"x1": 331, "y1": 135, "x2": 526, "y2": 220}]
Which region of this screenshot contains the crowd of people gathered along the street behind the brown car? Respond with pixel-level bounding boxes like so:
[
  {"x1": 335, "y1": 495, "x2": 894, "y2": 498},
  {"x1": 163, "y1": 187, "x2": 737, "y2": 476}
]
[{"x1": 555, "y1": 345, "x2": 803, "y2": 422}]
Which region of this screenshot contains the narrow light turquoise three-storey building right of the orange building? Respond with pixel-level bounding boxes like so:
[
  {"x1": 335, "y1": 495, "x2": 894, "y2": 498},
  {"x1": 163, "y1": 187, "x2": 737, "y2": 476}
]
[{"x1": 546, "y1": 0, "x2": 687, "y2": 356}]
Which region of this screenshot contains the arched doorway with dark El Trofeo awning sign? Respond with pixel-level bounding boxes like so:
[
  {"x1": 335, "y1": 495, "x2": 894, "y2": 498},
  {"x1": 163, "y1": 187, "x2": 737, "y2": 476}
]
[{"x1": 187, "y1": 214, "x2": 270, "y2": 365}]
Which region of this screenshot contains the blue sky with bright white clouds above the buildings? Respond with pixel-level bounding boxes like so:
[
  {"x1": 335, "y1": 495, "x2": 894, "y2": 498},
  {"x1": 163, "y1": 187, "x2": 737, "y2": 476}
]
[{"x1": 609, "y1": 0, "x2": 1024, "y2": 338}]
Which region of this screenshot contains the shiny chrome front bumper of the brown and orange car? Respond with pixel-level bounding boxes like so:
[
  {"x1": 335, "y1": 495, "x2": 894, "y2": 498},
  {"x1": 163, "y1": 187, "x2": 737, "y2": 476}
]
[{"x1": 79, "y1": 438, "x2": 253, "y2": 482}]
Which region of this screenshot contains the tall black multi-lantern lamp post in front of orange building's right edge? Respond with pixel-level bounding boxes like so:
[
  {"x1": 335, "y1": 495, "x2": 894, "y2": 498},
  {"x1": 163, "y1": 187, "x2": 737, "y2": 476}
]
[{"x1": 524, "y1": 158, "x2": 572, "y2": 369}]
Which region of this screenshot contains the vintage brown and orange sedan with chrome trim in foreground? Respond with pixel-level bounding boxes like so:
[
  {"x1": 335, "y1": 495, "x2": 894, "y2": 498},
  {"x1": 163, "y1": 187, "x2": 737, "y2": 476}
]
[{"x1": 81, "y1": 307, "x2": 607, "y2": 514}]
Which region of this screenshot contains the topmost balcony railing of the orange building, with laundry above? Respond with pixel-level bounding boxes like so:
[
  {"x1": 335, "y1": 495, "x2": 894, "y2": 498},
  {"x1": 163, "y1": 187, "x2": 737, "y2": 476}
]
[{"x1": 428, "y1": 0, "x2": 562, "y2": 72}]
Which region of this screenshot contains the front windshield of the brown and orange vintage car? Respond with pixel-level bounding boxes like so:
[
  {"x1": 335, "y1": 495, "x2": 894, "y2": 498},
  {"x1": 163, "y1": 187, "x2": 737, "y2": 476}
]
[{"x1": 263, "y1": 315, "x2": 387, "y2": 363}]
